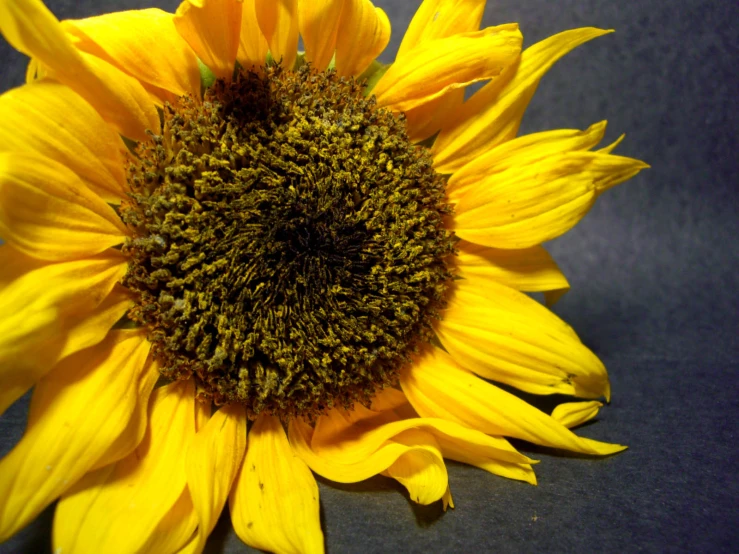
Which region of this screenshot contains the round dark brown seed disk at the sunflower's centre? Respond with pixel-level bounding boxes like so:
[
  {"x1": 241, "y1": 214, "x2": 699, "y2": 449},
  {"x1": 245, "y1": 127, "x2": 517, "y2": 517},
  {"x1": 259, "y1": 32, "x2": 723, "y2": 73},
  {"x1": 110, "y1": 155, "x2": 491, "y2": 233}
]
[{"x1": 122, "y1": 67, "x2": 454, "y2": 417}]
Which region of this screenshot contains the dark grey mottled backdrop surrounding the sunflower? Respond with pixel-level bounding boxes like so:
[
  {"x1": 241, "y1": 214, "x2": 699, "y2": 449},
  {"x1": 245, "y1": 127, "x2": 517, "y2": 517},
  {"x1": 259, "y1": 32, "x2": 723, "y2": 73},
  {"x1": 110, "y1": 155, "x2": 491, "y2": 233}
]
[{"x1": 0, "y1": 0, "x2": 739, "y2": 553}]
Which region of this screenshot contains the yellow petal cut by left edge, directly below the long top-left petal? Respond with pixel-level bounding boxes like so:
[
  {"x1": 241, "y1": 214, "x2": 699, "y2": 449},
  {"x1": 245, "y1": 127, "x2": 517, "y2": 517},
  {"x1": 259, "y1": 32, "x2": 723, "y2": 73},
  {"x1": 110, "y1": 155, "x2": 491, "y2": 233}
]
[{"x1": 0, "y1": 82, "x2": 126, "y2": 202}]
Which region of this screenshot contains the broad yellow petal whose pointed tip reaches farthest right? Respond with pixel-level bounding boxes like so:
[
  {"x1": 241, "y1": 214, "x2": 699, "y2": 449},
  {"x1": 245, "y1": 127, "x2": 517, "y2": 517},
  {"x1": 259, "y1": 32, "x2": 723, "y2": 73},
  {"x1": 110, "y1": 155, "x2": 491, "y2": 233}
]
[{"x1": 454, "y1": 152, "x2": 649, "y2": 249}]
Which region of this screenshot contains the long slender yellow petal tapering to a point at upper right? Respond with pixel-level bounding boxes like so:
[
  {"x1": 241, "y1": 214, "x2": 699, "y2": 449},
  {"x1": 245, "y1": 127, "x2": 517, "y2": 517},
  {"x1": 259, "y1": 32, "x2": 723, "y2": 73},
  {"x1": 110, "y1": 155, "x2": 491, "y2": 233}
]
[{"x1": 432, "y1": 28, "x2": 610, "y2": 173}]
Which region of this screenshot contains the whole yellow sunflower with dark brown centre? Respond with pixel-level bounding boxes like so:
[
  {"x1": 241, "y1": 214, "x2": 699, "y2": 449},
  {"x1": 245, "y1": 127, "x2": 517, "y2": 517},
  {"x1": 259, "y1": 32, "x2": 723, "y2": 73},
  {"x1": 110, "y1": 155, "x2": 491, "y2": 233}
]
[{"x1": 0, "y1": 0, "x2": 646, "y2": 553}]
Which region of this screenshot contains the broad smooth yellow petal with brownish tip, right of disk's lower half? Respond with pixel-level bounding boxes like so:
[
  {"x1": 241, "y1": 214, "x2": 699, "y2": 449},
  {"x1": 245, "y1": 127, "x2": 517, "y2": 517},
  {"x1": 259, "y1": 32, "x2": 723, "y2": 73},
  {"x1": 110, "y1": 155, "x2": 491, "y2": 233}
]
[{"x1": 436, "y1": 279, "x2": 609, "y2": 398}]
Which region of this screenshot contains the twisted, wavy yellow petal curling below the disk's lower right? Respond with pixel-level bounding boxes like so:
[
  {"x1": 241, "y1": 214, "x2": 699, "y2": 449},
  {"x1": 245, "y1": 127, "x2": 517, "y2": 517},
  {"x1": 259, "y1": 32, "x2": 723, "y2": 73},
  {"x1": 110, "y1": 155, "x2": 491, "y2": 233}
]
[{"x1": 298, "y1": 389, "x2": 535, "y2": 496}]
